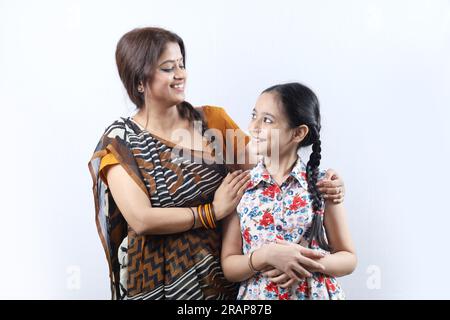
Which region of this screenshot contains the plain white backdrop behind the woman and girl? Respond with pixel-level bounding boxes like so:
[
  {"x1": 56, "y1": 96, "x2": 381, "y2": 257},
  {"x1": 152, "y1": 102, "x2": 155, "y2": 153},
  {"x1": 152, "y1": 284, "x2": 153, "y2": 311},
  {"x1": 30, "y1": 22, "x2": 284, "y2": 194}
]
[{"x1": 0, "y1": 0, "x2": 450, "y2": 299}]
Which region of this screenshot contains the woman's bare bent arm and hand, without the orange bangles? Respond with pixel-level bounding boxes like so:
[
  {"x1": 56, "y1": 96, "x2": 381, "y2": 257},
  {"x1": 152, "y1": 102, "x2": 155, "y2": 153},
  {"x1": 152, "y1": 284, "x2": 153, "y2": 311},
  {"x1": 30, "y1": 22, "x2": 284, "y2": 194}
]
[{"x1": 106, "y1": 164, "x2": 248, "y2": 235}]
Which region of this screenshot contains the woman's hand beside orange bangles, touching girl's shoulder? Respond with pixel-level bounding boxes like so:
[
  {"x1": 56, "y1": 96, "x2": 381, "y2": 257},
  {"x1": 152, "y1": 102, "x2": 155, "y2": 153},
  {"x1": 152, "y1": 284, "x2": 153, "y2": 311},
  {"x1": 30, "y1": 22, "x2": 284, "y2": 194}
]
[{"x1": 213, "y1": 170, "x2": 250, "y2": 220}]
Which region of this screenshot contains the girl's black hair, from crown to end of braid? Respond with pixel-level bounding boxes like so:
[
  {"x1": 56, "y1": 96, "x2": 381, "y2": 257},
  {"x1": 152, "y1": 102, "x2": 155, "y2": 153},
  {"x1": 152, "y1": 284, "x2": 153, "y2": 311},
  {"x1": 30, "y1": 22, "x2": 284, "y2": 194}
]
[{"x1": 262, "y1": 82, "x2": 330, "y2": 250}]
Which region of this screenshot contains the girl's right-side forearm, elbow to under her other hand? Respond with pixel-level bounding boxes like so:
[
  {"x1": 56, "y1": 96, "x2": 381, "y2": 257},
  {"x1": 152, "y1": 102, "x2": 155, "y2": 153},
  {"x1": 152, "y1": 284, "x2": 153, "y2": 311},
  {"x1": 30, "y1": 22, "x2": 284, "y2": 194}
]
[{"x1": 317, "y1": 251, "x2": 357, "y2": 277}]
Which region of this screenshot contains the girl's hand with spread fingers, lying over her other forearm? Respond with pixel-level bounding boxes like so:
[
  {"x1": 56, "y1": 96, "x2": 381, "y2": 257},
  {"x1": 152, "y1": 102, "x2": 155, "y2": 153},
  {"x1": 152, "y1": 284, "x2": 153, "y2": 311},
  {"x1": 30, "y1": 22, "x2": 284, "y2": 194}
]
[{"x1": 265, "y1": 239, "x2": 325, "y2": 281}]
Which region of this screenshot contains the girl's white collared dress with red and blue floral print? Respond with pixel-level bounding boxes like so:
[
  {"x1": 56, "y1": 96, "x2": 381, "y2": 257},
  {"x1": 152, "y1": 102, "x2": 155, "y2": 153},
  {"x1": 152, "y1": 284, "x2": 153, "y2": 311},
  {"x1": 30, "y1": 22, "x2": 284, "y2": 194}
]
[{"x1": 237, "y1": 157, "x2": 345, "y2": 300}]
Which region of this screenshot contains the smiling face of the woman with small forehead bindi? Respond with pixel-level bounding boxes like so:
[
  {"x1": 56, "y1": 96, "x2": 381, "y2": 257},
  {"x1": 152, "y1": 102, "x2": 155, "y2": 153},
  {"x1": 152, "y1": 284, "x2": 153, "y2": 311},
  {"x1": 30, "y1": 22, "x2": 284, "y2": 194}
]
[{"x1": 145, "y1": 42, "x2": 187, "y2": 106}]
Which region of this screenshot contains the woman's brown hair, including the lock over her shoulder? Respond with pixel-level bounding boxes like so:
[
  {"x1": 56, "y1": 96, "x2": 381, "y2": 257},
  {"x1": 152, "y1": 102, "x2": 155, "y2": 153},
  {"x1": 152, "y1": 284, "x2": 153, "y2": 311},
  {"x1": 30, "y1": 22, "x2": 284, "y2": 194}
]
[{"x1": 116, "y1": 27, "x2": 205, "y2": 130}]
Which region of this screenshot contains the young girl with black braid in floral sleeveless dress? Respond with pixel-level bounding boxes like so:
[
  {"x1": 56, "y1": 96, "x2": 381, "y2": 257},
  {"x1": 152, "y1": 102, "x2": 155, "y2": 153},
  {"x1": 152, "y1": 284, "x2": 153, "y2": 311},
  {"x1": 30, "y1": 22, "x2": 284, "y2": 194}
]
[{"x1": 221, "y1": 83, "x2": 356, "y2": 300}]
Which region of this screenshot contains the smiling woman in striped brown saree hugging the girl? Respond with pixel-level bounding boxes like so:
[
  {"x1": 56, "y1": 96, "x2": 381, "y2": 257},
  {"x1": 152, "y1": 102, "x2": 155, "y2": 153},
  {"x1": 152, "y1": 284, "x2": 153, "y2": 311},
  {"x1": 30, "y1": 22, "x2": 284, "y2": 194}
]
[{"x1": 89, "y1": 28, "x2": 343, "y2": 299}]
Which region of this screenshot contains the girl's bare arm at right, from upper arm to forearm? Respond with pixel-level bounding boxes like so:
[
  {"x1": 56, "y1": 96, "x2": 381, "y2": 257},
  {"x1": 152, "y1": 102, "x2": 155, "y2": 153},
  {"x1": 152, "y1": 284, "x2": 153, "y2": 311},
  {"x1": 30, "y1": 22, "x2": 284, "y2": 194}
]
[{"x1": 319, "y1": 201, "x2": 357, "y2": 277}]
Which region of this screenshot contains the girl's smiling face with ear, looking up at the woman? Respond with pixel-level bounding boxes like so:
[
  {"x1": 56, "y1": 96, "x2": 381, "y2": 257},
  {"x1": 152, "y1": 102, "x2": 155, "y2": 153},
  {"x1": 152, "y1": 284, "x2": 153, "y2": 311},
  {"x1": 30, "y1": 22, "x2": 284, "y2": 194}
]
[{"x1": 249, "y1": 92, "x2": 308, "y2": 157}]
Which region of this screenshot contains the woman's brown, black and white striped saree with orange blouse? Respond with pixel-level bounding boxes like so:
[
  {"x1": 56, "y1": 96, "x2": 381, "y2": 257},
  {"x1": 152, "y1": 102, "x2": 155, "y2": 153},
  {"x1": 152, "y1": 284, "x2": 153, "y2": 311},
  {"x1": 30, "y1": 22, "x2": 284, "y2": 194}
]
[{"x1": 89, "y1": 106, "x2": 248, "y2": 300}]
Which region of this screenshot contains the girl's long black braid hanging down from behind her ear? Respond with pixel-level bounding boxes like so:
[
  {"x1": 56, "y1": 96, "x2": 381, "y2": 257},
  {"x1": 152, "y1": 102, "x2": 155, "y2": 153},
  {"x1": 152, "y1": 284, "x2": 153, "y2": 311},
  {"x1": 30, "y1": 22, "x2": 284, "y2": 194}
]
[{"x1": 306, "y1": 126, "x2": 330, "y2": 251}]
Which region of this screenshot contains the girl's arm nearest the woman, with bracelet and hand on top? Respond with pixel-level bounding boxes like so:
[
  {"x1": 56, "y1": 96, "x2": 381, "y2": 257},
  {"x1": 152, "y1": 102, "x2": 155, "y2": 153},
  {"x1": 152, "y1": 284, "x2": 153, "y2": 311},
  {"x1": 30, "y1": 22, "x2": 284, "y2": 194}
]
[{"x1": 221, "y1": 213, "x2": 324, "y2": 282}]
